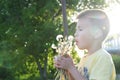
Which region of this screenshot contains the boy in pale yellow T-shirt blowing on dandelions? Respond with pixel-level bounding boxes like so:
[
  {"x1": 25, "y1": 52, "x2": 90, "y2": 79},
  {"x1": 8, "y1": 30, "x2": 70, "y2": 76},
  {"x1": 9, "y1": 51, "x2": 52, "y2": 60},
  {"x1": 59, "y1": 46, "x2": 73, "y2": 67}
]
[{"x1": 55, "y1": 9, "x2": 116, "y2": 80}]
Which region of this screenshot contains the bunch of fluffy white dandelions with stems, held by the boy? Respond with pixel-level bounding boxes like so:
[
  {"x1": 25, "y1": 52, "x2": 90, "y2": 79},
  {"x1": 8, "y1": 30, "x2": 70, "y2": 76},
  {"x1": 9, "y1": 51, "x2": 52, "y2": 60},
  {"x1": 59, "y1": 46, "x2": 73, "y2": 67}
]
[{"x1": 52, "y1": 35, "x2": 74, "y2": 80}]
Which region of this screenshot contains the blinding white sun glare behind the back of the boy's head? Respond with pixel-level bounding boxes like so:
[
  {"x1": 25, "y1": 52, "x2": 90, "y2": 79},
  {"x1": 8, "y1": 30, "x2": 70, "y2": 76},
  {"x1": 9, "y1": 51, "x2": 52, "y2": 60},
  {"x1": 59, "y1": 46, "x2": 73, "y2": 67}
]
[{"x1": 105, "y1": 4, "x2": 120, "y2": 35}]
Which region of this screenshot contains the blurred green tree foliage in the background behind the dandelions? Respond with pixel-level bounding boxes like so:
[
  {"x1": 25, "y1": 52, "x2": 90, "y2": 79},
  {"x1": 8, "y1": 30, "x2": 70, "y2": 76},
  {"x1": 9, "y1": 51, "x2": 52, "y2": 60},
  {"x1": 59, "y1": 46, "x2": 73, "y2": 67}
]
[{"x1": 0, "y1": 0, "x2": 109, "y2": 80}]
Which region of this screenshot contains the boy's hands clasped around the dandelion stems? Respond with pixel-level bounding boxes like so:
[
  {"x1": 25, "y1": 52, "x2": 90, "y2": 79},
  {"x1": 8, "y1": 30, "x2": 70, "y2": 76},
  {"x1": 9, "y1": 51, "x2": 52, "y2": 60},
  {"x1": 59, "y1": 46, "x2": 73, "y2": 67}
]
[{"x1": 54, "y1": 55, "x2": 74, "y2": 70}]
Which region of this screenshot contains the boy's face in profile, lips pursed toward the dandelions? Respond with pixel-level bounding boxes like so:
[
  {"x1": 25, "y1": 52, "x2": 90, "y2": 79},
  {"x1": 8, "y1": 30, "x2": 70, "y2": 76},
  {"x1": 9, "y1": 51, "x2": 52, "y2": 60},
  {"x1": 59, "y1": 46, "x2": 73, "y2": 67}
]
[{"x1": 75, "y1": 18, "x2": 94, "y2": 49}]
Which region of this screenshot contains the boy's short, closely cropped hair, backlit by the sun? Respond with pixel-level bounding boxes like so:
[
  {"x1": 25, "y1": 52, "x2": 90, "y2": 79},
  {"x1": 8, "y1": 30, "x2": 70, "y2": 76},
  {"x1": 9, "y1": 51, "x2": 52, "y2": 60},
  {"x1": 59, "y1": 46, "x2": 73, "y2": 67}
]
[{"x1": 77, "y1": 9, "x2": 110, "y2": 39}]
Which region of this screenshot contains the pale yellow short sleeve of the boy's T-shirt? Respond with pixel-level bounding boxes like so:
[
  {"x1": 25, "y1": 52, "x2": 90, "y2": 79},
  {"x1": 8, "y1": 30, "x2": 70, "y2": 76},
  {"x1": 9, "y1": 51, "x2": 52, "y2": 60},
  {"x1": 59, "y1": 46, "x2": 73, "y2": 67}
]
[{"x1": 89, "y1": 56, "x2": 115, "y2": 80}]
